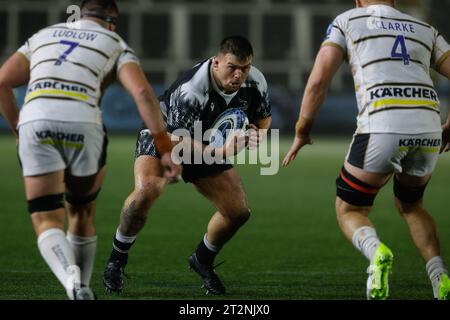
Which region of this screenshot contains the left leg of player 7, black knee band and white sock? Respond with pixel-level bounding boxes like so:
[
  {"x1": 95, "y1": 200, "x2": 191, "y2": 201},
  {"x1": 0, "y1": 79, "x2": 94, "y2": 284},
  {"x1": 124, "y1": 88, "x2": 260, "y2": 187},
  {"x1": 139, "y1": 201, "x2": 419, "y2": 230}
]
[{"x1": 24, "y1": 171, "x2": 89, "y2": 299}]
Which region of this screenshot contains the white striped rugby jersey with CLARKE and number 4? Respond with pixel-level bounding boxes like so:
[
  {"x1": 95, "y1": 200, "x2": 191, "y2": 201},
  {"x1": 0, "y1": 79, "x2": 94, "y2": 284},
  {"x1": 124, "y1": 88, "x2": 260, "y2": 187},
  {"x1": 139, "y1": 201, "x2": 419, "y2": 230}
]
[{"x1": 322, "y1": 5, "x2": 450, "y2": 134}]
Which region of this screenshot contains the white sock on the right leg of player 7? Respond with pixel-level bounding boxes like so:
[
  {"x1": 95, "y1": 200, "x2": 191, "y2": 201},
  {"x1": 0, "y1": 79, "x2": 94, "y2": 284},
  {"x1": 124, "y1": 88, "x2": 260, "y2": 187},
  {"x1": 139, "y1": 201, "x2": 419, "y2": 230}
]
[{"x1": 67, "y1": 232, "x2": 97, "y2": 287}]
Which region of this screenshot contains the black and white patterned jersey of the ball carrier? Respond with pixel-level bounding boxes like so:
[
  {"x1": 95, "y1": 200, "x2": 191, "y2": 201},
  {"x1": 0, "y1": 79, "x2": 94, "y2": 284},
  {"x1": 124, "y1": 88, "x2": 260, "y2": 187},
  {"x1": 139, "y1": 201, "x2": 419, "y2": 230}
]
[{"x1": 159, "y1": 58, "x2": 271, "y2": 135}]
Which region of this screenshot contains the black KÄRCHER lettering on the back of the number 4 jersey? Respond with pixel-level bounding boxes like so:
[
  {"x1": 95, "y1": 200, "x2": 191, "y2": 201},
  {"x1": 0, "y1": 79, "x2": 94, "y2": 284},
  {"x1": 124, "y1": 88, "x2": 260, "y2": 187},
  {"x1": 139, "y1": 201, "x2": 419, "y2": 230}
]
[{"x1": 369, "y1": 87, "x2": 439, "y2": 102}]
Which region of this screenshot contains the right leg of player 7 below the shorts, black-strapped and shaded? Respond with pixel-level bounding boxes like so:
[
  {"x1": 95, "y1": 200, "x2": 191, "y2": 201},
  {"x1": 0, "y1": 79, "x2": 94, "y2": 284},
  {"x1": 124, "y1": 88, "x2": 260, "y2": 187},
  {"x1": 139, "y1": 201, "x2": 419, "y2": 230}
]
[{"x1": 65, "y1": 168, "x2": 106, "y2": 287}]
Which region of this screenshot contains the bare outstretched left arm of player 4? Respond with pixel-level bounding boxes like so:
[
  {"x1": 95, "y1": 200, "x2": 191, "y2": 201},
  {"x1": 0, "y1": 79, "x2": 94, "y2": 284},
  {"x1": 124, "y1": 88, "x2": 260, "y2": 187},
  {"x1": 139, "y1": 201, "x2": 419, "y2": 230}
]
[{"x1": 283, "y1": 45, "x2": 344, "y2": 166}]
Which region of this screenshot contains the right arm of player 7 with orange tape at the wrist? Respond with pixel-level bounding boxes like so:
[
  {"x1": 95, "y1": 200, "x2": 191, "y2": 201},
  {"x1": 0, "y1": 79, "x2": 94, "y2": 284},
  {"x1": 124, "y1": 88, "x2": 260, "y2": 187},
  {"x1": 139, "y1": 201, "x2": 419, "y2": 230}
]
[{"x1": 117, "y1": 63, "x2": 181, "y2": 181}]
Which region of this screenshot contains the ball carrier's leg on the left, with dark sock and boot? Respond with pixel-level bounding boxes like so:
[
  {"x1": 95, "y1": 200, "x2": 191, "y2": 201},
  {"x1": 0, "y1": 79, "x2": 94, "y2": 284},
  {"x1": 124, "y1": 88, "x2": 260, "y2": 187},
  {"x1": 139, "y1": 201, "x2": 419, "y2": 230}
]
[{"x1": 103, "y1": 156, "x2": 167, "y2": 292}]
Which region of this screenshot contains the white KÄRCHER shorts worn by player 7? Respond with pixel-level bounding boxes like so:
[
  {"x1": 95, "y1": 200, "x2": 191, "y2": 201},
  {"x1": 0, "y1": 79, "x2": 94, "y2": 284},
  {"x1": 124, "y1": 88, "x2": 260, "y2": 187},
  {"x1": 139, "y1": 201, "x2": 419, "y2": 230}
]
[{"x1": 18, "y1": 120, "x2": 108, "y2": 177}]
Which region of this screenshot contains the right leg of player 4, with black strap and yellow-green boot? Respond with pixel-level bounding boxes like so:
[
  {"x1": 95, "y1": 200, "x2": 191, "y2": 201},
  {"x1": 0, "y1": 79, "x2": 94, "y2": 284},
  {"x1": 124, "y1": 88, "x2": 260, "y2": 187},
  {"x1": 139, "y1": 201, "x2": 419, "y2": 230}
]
[{"x1": 395, "y1": 174, "x2": 450, "y2": 299}]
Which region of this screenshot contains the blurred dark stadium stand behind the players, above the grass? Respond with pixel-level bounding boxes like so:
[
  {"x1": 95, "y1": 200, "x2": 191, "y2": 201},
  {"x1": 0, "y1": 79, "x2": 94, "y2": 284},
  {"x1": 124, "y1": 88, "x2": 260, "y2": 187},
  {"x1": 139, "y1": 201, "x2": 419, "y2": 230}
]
[{"x1": 0, "y1": 0, "x2": 450, "y2": 133}]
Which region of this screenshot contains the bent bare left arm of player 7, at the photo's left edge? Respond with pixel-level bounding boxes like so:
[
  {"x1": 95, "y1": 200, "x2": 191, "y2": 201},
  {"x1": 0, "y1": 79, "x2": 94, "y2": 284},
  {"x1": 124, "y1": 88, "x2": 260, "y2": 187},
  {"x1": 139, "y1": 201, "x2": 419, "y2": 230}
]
[{"x1": 0, "y1": 52, "x2": 30, "y2": 138}]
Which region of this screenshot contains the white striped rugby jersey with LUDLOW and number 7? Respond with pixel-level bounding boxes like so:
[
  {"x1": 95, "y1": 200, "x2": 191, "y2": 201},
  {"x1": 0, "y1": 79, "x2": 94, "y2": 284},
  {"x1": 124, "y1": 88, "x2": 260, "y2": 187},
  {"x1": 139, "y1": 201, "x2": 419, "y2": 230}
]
[{"x1": 18, "y1": 20, "x2": 139, "y2": 125}]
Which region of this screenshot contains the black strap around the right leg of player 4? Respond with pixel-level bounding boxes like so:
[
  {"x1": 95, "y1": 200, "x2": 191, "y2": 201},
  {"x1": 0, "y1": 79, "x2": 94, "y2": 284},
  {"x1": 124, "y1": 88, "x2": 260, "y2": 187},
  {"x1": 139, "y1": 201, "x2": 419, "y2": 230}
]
[{"x1": 394, "y1": 177, "x2": 427, "y2": 215}]
